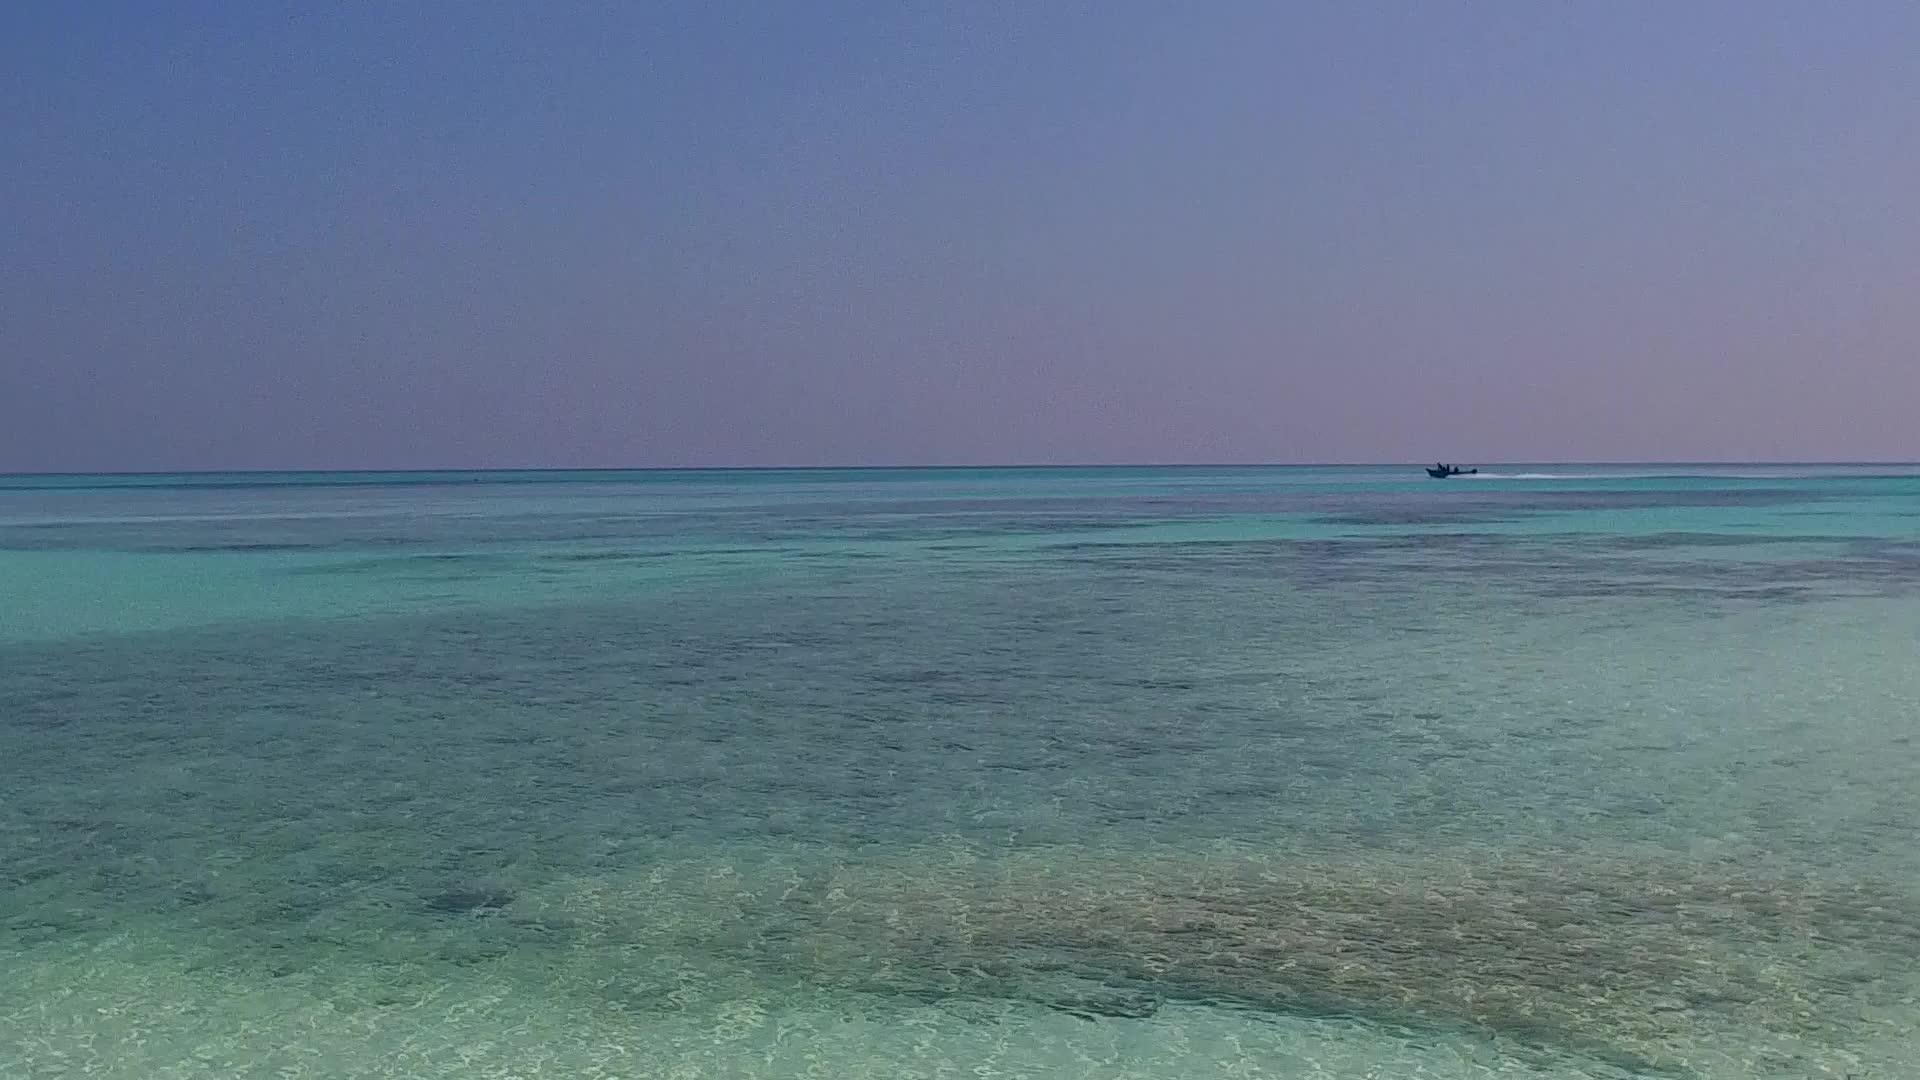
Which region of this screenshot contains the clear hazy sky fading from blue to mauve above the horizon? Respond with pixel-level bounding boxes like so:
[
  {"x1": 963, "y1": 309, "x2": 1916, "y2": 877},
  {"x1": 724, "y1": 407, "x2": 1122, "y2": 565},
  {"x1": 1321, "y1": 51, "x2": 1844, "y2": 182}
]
[{"x1": 0, "y1": 0, "x2": 1920, "y2": 471}]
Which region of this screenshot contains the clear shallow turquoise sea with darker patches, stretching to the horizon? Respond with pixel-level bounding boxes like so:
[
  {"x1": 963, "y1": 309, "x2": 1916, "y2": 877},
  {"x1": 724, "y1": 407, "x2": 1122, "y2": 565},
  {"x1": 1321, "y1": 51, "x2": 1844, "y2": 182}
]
[{"x1": 0, "y1": 467, "x2": 1920, "y2": 1080}]
